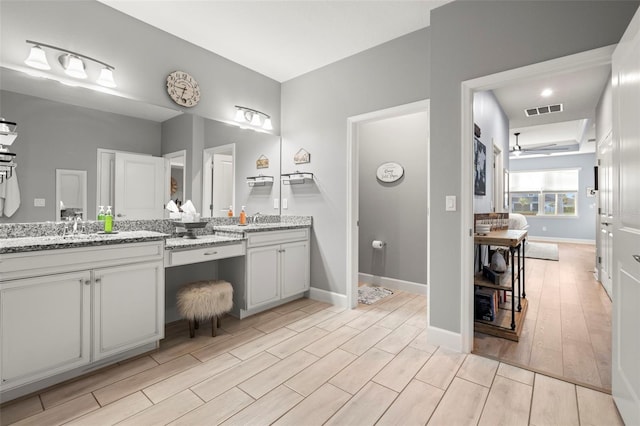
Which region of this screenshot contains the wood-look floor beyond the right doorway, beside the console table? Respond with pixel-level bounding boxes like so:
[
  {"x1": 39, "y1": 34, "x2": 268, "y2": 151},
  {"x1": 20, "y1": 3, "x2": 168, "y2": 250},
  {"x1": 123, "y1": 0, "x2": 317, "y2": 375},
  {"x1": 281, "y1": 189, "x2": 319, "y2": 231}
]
[{"x1": 473, "y1": 243, "x2": 611, "y2": 392}]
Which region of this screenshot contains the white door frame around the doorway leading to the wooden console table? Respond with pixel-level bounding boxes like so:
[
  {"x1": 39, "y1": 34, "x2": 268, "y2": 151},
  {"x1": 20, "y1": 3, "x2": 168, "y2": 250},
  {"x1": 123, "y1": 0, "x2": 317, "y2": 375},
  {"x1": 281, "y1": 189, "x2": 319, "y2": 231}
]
[{"x1": 460, "y1": 44, "x2": 616, "y2": 353}]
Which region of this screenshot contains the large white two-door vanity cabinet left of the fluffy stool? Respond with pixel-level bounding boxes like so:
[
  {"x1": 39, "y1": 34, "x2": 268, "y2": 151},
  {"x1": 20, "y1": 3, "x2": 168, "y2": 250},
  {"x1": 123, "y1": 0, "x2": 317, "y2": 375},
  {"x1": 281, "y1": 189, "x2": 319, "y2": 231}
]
[{"x1": 0, "y1": 240, "x2": 164, "y2": 400}]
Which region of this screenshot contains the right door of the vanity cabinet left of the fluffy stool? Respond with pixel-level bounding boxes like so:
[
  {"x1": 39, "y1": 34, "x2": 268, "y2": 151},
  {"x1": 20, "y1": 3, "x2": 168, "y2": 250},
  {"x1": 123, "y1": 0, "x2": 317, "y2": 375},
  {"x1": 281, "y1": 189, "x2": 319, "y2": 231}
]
[{"x1": 93, "y1": 262, "x2": 164, "y2": 360}]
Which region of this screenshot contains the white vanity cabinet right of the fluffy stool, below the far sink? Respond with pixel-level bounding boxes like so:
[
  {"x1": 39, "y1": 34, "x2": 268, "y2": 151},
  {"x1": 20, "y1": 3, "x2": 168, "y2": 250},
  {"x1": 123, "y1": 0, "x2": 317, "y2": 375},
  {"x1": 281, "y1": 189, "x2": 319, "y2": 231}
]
[{"x1": 245, "y1": 228, "x2": 310, "y2": 312}]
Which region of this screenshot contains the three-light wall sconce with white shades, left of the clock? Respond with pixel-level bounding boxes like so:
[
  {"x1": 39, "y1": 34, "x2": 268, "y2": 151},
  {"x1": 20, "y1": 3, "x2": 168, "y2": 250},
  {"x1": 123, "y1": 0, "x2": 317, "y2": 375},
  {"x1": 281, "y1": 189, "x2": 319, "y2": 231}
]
[{"x1": 24, "y1": 40, "x2": 116, "y2": 88}]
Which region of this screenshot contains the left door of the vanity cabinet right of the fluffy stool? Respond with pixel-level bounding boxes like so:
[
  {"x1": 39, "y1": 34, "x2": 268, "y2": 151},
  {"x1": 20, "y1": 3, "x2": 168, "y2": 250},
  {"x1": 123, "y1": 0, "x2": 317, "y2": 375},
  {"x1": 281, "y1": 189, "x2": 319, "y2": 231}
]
[{"x1": 247, "y1": 246, "x2": 280, "y2": 309}]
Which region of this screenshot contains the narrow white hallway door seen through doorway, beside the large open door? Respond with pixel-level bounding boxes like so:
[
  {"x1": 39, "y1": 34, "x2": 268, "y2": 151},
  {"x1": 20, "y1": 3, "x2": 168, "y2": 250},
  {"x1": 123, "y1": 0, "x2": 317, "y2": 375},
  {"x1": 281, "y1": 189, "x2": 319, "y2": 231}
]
[{"x1": 598, "y1": 134, "x2": 613, "y2": 297}]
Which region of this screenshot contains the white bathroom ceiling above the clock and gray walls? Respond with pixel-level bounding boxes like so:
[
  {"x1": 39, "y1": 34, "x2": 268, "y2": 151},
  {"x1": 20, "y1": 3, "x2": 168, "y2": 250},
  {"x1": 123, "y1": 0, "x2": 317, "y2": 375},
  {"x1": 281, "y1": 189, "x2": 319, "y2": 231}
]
[{"x1": 99, "y1": 0, "x2": 452, "y2": 82}]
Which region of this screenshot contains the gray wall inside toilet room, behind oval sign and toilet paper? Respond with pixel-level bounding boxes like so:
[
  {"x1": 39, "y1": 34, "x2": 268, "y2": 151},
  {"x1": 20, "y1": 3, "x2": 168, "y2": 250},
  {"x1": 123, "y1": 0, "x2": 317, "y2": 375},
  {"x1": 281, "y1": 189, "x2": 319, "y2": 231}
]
[{"x1": 358, "y1": 112, "x2": 429, "y2": 284}]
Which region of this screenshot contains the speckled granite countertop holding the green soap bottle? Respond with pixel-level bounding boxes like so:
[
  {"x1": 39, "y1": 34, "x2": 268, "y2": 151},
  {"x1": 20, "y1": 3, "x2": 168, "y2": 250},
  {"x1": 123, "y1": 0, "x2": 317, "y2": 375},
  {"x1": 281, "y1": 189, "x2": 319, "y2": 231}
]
[{"x1": 0, "y1": 231, "x2": 168, "y2": 254}]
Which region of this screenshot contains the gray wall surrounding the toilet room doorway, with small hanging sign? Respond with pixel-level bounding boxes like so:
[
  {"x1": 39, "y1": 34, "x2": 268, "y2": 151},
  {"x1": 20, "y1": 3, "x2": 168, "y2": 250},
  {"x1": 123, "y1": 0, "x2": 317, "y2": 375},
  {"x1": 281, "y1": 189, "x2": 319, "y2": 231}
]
[{"x1": 282, "y1": 29, "x2": 430, "y2": 294}]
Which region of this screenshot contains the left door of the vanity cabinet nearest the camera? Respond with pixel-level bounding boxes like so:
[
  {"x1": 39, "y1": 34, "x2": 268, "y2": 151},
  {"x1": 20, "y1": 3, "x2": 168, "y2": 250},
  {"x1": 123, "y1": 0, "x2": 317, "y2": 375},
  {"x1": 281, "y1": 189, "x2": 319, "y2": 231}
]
[{"x1": 0, "y1": 272, "x2": 91, "y2": 389}]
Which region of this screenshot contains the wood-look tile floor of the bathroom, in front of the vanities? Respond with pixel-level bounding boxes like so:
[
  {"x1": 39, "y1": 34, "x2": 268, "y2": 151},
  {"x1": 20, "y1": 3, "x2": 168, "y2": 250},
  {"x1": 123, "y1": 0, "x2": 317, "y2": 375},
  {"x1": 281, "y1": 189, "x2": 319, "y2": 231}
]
[{"x1": 0, "y1": 282, "x2": 622, "y2": 426}]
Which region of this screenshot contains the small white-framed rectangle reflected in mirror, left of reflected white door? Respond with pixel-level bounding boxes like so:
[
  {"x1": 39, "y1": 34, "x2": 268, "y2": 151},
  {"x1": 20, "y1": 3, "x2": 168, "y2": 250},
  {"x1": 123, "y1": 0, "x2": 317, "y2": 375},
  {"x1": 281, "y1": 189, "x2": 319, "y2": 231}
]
[{"x1": 55, "y1": 169, "x2": 87, "y2": 221}]
